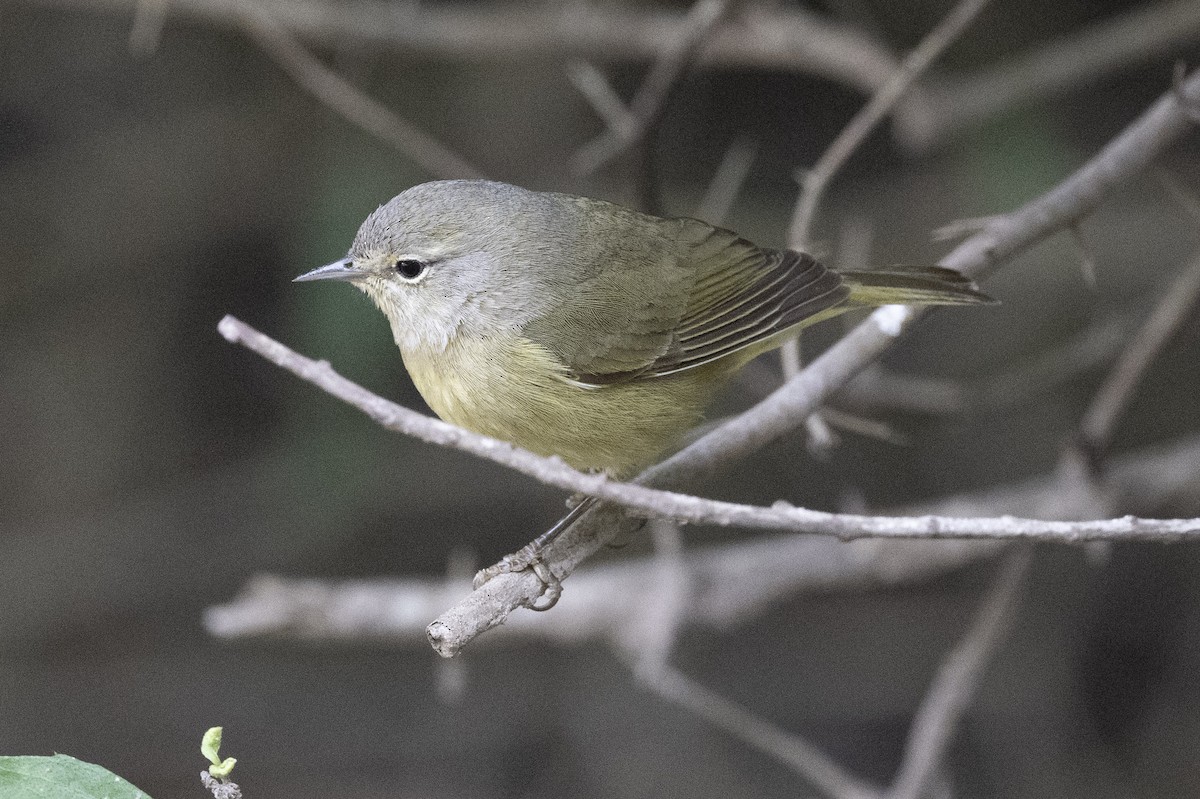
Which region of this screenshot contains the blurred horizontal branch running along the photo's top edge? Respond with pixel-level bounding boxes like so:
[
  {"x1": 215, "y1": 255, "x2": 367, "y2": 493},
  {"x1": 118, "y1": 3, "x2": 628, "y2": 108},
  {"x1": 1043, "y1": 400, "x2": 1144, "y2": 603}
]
[{"x1": 16, "y1": 0, "x2": 895, "y2": 92}]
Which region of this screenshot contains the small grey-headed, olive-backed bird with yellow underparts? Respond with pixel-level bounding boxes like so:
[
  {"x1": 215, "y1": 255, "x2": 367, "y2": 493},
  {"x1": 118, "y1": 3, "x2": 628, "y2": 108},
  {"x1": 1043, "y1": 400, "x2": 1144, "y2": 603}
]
[{"x1": 295, "y1": 180, "x2": 991, "y2": 479}]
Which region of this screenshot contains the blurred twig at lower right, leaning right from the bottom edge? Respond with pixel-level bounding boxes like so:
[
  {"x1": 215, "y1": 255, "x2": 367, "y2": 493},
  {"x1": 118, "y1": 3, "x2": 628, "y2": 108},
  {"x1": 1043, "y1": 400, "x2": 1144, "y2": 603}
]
[{"x1": 886, "y1": 547, "x2": 1031, "y2": 799}]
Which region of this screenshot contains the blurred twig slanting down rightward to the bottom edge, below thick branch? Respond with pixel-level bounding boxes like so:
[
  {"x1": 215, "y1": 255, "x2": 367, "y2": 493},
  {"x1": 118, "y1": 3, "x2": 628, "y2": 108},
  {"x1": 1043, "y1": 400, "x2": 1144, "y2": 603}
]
[{"x1": 642, "y1": 666, "x2": 878, "y2": 799}]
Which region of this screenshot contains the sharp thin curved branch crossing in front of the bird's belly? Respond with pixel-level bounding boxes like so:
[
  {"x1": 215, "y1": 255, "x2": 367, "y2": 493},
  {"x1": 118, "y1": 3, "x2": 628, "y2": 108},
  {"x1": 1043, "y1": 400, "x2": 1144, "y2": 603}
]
[{"x1": 218, "y1": 317, "x2": 1200, "y2": 542}]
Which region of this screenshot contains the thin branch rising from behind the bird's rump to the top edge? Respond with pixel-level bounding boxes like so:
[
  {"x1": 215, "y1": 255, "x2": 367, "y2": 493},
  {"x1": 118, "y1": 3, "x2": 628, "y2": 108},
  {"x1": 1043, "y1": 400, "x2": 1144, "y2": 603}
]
[{"x1": 787, "y1": 0, "x2": 989, "y2": 250}]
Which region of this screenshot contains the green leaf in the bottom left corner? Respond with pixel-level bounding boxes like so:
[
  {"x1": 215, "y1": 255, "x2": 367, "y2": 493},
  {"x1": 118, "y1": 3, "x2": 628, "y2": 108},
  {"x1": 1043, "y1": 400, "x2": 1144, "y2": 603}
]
[{"x1": 0, "y1": 755, "x2": 150, "y2": 799}]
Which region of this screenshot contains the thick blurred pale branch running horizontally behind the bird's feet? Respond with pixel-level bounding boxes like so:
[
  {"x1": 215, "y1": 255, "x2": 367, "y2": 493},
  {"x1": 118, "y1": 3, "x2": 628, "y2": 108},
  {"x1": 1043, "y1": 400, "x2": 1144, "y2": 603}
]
[{"x1": 204, "y1": 429, "x2": 1200, "y2": 644}]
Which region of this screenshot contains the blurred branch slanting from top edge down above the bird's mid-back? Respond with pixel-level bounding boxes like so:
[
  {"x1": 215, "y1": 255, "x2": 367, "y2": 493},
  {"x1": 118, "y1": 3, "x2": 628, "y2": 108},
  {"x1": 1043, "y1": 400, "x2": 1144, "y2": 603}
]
[{"x1": 572, "y1": 0, "x2": 732, "y2": 175}]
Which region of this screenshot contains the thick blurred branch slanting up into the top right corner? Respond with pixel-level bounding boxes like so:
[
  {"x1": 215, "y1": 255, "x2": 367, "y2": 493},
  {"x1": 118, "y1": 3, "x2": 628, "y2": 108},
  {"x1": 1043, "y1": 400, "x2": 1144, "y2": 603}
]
[{"x1": 894, "y1": 0, "x2": 1200, "y2": 152}]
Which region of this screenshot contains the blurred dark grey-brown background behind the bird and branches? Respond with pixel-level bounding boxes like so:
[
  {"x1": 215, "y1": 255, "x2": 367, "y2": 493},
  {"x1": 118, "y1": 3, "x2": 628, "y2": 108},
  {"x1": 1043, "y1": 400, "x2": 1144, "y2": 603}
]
[{"x1": 0, "y1": 0, "x2": 1200, "y2": 799}]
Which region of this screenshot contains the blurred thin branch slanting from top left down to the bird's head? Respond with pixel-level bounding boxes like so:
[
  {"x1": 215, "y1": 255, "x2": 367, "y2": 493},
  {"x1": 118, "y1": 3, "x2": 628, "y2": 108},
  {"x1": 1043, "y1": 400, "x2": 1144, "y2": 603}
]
[{"x1": 236, "y1": 2, "x2": 484, "y2": 178}]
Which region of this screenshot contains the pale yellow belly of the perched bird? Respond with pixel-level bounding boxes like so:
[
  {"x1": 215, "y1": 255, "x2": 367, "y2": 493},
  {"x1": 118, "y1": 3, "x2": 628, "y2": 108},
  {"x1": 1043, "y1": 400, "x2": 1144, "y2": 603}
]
[{"x1": 403, "y1": 328, "x2": 725, "y2": 476}]
